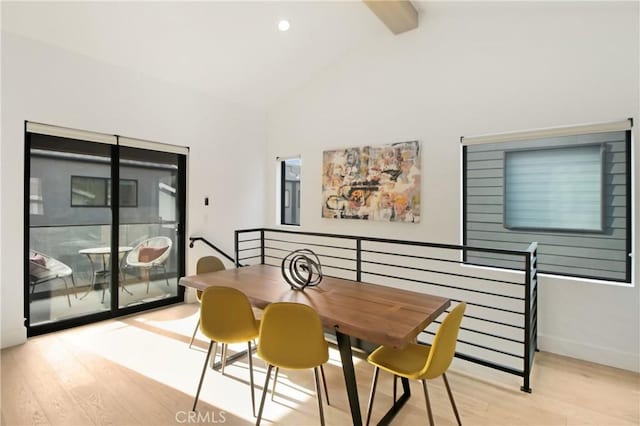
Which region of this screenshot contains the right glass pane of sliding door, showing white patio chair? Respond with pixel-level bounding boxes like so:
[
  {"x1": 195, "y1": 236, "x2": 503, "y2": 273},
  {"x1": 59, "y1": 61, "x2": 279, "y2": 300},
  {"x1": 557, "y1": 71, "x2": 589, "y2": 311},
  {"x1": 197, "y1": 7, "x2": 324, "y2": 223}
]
[{"x1": 119, "y1": 147, "x2": 181, "y2": 307}]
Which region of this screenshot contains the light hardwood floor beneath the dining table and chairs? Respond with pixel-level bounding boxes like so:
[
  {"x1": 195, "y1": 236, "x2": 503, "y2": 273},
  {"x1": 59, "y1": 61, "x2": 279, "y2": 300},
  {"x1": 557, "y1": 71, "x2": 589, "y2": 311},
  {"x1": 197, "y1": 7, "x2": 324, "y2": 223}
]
[{"x1": 0, "y1": 304, "x2": 640, "y2": 426}]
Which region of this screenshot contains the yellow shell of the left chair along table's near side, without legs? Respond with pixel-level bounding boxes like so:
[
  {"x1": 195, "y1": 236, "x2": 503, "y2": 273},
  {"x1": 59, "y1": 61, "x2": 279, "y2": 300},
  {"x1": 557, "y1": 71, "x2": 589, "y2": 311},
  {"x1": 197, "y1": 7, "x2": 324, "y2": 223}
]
[{"x1": 200, "y1": 287, "x2": 259, "y2": 343}]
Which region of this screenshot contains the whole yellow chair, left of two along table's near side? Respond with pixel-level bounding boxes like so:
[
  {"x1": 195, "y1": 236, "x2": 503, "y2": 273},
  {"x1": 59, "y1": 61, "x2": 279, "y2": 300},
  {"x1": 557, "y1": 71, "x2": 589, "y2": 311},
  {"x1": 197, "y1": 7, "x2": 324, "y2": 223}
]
[{"x1": 193, "y1": 287, "x2": 260, "y2": 416}]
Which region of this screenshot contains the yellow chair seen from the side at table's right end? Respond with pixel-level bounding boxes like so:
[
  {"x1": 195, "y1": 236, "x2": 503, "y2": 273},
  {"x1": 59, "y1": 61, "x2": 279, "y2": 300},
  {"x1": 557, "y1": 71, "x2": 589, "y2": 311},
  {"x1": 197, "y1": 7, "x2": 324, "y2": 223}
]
[{"x1": 366, "y1": 302, "x2": 467, "y2": 426}]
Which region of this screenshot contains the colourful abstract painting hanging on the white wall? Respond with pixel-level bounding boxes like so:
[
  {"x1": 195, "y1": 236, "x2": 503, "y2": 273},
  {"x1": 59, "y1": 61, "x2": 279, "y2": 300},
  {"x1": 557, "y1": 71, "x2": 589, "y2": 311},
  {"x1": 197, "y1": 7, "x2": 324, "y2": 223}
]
[{"x1": 322, "y1": 141, "x2": 420, "y2": 223}]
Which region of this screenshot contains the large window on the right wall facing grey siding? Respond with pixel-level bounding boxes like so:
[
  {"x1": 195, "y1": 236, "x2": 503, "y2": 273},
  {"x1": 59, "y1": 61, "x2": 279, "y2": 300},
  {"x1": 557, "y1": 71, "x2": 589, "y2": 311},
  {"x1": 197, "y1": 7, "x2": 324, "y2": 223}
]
[{"x1": 461, "y1": 120, "x2": 633, "y2": 283}]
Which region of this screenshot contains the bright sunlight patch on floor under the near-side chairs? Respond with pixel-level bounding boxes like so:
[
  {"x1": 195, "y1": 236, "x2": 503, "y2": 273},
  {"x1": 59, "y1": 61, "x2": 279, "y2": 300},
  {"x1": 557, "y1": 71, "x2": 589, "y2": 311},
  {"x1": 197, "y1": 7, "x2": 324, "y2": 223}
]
[{"x1": 52, "y1": 309, "x2": 350, "y2": 423}]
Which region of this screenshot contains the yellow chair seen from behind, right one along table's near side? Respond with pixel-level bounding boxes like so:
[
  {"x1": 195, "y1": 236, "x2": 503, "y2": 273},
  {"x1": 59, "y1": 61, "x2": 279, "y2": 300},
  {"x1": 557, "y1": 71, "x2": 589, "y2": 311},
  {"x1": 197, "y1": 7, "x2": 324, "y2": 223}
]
[{"x1": 256, "y1": 302, "x2": 329, "y2": 425}]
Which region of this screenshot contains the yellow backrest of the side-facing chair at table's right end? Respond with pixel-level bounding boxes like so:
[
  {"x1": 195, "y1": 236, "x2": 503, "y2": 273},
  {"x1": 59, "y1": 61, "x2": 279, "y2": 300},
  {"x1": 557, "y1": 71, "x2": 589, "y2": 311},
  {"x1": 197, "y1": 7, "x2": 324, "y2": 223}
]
[{"x1": 420, "y1": 302, "x2": 467, "y2": 379}]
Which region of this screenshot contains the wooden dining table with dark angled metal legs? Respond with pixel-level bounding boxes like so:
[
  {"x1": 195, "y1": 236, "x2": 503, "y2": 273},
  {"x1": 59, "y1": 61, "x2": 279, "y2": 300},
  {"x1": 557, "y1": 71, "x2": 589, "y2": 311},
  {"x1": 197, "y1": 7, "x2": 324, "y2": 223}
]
[{"x1": 180, "y1": 264, "x2": 451, "y2": 425}]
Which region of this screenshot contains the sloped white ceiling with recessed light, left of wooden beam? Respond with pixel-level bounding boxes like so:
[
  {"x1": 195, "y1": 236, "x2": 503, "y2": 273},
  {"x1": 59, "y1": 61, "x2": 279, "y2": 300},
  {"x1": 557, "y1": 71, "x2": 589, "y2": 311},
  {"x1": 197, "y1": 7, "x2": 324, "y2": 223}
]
[{"x1": 1, "y1": 1, "x2": 424, "y2": 108}]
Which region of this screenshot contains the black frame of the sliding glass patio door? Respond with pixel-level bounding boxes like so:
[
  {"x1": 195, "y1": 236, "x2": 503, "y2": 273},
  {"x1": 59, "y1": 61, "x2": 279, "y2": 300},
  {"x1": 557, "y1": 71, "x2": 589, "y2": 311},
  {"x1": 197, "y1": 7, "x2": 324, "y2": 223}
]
[{"x1": 23, "y1": 122, "x2": 187, "y2": 337}]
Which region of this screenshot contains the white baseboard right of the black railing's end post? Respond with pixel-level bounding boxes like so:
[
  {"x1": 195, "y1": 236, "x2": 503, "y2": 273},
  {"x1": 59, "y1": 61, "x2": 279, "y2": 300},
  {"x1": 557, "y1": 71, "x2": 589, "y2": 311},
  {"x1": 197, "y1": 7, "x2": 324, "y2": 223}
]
[{"x1": 538, "y1": 334, "x2": 640, "y2": 373}]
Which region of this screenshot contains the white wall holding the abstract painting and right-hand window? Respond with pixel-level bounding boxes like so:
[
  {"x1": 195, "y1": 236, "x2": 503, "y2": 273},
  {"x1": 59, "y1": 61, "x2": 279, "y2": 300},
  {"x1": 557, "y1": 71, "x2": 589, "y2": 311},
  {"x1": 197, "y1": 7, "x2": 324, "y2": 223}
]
[{"x1": 267, "y1": 2, "x2": 640, "y2": 371}]
